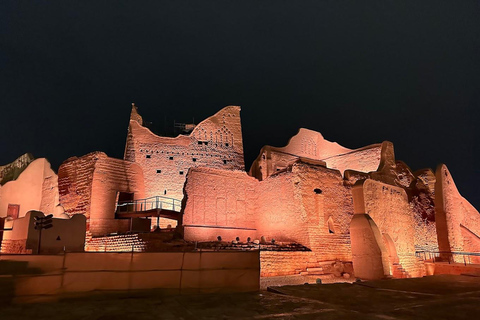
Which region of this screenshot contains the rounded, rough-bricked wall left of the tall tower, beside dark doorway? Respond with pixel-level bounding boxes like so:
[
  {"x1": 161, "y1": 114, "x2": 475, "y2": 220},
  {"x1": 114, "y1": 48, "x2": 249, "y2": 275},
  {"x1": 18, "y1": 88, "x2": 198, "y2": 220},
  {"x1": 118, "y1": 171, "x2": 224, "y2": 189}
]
[{"x1": 59, "y1": 152, "x2": 145, "y2": 235}]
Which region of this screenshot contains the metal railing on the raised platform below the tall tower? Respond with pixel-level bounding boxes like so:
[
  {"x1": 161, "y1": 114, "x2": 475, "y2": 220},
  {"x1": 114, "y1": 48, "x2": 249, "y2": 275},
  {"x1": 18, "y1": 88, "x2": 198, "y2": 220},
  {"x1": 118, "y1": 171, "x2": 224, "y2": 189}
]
[{"x1": 115, "y1": 196, "x2": 182, "y2": 213}]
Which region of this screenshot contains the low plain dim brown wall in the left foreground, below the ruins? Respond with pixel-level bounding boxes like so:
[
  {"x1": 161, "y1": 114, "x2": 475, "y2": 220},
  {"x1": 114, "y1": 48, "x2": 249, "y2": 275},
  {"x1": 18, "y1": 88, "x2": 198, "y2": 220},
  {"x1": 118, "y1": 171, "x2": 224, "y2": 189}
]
[{"x1": 0, "y1": 251, "x2": 260, "y2": 299}]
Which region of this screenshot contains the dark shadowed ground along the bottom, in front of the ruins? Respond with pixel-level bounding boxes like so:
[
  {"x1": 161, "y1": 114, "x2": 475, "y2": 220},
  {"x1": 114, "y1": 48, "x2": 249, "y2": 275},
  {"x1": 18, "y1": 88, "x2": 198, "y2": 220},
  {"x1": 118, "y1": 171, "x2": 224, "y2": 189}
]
[{"x1": 0, "y1": 275, "x2": 480, "y2": 320}]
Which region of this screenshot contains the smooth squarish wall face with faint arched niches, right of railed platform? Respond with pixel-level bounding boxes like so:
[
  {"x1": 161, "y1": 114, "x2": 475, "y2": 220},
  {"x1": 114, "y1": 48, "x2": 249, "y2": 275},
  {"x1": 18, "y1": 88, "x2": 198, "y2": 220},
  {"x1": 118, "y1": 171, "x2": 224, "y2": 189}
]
[{"x1": 183, "y1": 168, "x2": 259, "y2": 241}]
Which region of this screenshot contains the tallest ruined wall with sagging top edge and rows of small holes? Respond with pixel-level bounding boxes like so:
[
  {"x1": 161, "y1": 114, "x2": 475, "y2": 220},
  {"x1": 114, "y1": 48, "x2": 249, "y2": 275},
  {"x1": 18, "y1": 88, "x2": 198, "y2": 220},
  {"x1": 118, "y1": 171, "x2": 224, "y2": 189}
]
[{"x1": 125, "y1": 106, "x2": 245, "y2": 200}]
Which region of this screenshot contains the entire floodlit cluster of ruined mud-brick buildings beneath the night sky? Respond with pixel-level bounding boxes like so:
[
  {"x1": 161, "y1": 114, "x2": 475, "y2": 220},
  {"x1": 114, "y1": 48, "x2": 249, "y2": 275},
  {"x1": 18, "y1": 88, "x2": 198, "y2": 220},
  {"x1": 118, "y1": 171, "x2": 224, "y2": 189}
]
[{"x1": 0, "y1": 105, "x2": 480, "y2": 279}]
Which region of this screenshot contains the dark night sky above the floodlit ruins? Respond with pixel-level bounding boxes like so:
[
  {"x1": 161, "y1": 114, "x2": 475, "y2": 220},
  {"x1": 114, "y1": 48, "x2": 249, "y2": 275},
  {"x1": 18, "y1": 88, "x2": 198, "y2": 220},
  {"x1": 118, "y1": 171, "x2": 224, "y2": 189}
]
[{"x1": 0, "y1": 0, "x2": 480, "y2": 208}]
